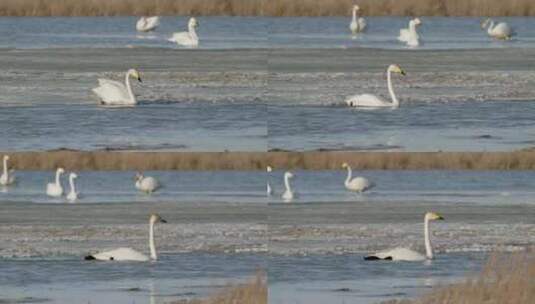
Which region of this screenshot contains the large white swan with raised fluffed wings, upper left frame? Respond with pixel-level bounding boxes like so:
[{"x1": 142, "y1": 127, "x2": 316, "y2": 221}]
[{"x1": 93, "y1": 69, "x2": 141, "y2": 105}]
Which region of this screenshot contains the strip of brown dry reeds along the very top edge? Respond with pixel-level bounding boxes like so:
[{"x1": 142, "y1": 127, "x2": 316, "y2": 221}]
[{"x1": 0, "y1": 0, "x2": 535, "y2": 16}]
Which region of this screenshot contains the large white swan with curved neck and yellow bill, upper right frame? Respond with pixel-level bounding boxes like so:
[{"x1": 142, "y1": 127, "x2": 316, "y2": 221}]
[{"x1": 346, "y1": 64, "x2": 405, "y2": 108}]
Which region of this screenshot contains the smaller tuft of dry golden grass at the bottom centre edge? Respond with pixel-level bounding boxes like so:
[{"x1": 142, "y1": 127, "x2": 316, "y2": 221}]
[{"x1": 173, "y1": 271, "x2": 268, "y2": 304}]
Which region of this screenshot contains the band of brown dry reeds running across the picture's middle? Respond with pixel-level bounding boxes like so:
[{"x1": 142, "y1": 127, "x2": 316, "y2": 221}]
[{"x1": 3, "y1": 151, "x2": 535, "y2": 170}]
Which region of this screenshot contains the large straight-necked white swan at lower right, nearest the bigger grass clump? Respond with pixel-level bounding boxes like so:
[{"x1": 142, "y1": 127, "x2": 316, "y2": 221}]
[{"x1": 364, "y1": 212, "x2": 444, "y2": 262}]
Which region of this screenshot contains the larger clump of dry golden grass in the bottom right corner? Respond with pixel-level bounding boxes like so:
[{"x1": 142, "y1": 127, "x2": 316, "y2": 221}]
[{"x1": 384, "y1": 253, "x2": 535, "y2": 304}]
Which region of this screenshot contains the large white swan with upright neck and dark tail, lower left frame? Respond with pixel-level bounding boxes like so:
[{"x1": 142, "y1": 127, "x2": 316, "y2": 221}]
[{"x1": 85, "y1": 214, "x2": 167, "y2": 262}]
